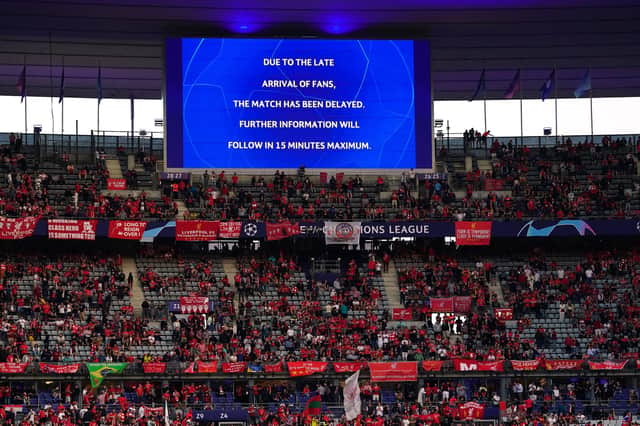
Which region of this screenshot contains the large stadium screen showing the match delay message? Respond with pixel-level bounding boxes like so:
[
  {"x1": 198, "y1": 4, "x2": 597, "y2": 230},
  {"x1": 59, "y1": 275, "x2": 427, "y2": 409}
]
[{"x1": 165, "y1": 38, "x2": 433, "y2": 169}]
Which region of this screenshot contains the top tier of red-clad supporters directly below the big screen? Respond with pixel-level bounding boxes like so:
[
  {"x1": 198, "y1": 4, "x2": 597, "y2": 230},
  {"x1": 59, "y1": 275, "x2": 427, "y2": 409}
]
[{"x1": 0, "y1": 137, "x2": 640, "y2": 221}]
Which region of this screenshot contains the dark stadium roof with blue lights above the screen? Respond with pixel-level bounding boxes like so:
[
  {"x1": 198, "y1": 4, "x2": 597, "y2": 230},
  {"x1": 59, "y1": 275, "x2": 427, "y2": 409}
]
[{"x1": 0, "y1": 0, "x2": 640, "y2": 99}]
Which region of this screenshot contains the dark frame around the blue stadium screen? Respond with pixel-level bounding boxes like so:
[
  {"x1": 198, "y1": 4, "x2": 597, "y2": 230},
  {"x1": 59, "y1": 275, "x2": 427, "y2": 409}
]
[{"x1": 162, "y1": 35, "x2": 436, "y2": 175}]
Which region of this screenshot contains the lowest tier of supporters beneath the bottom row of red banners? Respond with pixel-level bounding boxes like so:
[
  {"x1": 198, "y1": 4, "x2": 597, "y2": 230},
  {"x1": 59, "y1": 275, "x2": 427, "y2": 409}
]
[{"x1": 0, "y1": 378, "x2": 638, "y2": 426}]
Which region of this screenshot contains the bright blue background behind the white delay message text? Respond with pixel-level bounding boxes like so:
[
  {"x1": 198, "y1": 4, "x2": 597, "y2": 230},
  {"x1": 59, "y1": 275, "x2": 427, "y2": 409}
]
[{"x1": 167, "y1": 38, "x2": 431, "y2": 168}]
